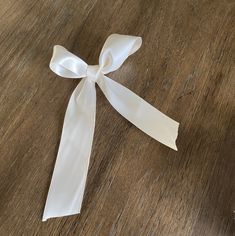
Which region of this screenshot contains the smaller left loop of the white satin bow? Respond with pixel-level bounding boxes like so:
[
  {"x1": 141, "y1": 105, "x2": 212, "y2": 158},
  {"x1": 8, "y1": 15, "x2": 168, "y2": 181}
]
[{"x1": 50, "y1": 45, "x2": 87, "y2": 78}]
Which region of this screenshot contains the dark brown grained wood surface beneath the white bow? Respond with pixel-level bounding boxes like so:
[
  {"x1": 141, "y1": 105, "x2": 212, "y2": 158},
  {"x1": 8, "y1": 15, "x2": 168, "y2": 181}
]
[{"x1": 0, "y1": 0, "x2": 235, "y2": 236}]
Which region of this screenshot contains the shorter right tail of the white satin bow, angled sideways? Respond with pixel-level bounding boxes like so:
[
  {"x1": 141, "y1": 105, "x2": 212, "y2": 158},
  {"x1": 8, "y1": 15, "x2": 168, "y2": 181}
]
[{"x1": 98, "y1": 76, "x2": 179, "y2": 150}]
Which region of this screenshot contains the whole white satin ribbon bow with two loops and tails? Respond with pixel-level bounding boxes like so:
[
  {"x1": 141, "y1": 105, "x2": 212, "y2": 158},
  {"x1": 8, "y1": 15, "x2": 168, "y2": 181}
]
[{"x1": 43, "y1": 34, "x2": 179, "y2": 221}]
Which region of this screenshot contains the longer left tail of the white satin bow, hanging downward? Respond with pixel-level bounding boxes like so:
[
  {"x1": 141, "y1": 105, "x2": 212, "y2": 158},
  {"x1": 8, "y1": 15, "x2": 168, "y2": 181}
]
[{"x1": 42, "y1": 79, "x2": 96, "y2": 221}]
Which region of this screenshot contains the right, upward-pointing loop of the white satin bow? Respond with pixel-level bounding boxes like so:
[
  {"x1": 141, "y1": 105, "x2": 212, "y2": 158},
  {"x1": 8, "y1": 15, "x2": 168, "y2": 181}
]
[{"x1": 99, "y1": 34, "x2": 142, "y2": 74}]
